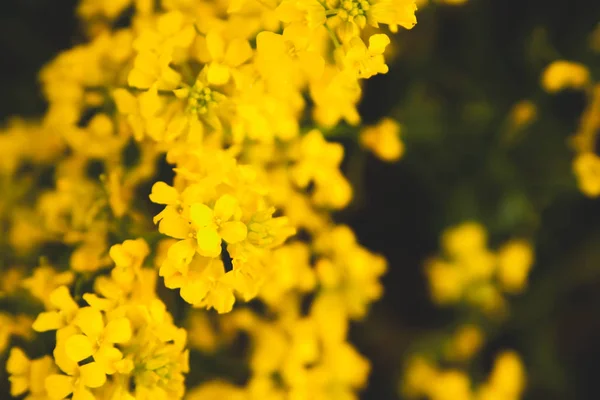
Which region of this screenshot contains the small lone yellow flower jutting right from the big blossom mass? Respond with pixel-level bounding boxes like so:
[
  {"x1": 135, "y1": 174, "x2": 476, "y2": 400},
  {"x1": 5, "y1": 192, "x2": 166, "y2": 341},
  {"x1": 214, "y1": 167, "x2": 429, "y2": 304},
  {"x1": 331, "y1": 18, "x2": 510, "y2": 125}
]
[{"x1": 360, "y1": 118, "x2": 404, "y2": 162}]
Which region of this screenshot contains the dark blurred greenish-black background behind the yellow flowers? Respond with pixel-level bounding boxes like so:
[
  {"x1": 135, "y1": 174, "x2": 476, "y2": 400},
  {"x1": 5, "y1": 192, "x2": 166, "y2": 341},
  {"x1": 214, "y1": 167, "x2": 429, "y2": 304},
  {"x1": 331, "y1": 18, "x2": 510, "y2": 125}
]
[{"x1": 0, "y1": 0, "x2": 600, "y2": 399}]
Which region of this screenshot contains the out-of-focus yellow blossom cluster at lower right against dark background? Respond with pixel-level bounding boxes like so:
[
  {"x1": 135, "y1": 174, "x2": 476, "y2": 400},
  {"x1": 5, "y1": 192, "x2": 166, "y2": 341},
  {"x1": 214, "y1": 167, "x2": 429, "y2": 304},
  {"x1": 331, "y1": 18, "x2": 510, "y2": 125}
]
[{"x1": 400, "y1": 222, "x2": 533, "y2": 400}]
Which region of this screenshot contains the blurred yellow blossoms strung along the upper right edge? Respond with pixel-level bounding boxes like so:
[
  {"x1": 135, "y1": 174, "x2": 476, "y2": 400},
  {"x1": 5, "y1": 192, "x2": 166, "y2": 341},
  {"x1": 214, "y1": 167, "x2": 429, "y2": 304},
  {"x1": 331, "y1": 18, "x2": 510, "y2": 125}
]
[{"x1": 541, "y1": 28, "x2": 600, "y2": 197}]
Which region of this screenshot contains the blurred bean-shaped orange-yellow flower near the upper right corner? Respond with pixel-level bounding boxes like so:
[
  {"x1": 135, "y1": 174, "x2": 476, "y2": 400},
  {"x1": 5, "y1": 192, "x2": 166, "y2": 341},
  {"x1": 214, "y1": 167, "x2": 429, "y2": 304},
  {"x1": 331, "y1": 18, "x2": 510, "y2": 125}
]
[{"x1": 542, "y1": 60, "x2": 590, "y2": 93}]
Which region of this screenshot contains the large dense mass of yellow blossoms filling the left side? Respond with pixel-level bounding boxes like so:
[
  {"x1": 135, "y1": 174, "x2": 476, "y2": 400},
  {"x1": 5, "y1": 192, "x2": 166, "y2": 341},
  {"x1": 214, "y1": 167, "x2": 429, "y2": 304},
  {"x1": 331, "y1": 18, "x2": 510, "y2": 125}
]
[{"x1": 0, "y1": 0, "x2": 416, "y2": 400}]
